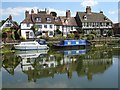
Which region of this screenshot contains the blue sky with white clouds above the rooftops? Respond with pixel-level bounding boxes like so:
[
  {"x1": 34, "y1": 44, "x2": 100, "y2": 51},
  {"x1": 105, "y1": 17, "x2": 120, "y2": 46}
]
[{"x1": 0, "y1": 0, "x2": 118, "y2": 23}]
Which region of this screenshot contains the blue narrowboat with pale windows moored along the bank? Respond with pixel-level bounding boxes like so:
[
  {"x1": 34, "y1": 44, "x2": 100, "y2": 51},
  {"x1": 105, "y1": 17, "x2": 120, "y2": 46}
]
[{"x1": 54, "y1": 40, "x2": 91, "y2": 47}]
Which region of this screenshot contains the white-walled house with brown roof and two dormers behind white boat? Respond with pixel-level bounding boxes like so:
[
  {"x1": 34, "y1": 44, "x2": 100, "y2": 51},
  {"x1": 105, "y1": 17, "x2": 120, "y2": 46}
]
[{"x1": 21, "y1": 10, "x2": 54, "y2": 39}]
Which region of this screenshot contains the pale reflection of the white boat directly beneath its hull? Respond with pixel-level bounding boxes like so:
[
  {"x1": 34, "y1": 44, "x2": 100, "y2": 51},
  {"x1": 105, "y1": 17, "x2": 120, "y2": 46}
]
[{"x1": 16, "y1": 50, "x2": 48, "y2": 58}]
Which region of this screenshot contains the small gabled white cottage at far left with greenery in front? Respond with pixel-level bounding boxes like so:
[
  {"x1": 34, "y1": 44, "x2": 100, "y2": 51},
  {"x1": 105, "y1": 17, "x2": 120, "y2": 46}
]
[{"x1": 0, "y1": 15, "x2": 19, "y2": 42}]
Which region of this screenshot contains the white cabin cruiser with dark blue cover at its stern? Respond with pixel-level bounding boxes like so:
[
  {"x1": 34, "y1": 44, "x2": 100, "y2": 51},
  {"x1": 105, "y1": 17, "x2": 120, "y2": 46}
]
[{"x1": 14, "y1": 39, "x2": 49, "y2": 50}]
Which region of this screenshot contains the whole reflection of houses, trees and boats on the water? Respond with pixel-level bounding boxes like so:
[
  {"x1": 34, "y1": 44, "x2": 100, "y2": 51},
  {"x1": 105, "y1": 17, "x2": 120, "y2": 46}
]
[{"x1": 2, "y1": 49, "x2": 112, "y2": 82}]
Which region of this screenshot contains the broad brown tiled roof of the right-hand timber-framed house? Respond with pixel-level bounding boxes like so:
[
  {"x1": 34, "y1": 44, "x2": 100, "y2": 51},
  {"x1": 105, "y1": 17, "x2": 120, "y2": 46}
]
[{"x1": 77, "y1": 12, "x2": 112, "y2": 22}]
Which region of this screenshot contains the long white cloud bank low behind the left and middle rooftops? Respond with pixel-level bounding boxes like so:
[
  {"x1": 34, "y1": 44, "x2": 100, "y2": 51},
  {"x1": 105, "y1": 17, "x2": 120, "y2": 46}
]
[{"x1": 0, "y1": 7, "x2": 75, "y2": 16}]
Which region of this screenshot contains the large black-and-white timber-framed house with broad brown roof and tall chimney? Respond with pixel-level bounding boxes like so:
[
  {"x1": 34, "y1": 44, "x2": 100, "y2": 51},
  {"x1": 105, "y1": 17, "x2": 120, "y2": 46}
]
[{"x1": 76, "y1": 6, "x2": 112, "y2": 35}]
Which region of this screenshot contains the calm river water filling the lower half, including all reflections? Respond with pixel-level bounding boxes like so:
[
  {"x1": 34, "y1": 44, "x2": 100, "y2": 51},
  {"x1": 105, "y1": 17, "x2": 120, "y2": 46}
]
[{"x1": 1, "y1": 49, "x2": 120, "y2": 88}]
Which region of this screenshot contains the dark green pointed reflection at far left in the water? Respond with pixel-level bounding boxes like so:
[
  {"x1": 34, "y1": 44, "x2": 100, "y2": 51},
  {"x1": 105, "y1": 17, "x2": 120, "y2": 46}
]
[{"x1": 2, "y1": 53, "x2": 21, "y2": 75}]
